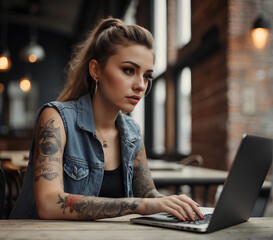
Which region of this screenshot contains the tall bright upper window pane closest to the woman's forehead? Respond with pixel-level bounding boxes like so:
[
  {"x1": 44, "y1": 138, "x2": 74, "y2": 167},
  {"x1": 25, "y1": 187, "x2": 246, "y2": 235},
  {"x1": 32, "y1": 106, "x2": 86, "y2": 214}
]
[{"x1": 154, "y1": 0, "x2": 167, "y2": 77}]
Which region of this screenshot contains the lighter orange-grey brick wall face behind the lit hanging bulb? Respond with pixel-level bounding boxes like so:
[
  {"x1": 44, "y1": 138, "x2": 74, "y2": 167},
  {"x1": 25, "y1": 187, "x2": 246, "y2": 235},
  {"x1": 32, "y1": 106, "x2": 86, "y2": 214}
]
[{"x1": 227, "y1": 0, "x2": 273, "y2": 167}]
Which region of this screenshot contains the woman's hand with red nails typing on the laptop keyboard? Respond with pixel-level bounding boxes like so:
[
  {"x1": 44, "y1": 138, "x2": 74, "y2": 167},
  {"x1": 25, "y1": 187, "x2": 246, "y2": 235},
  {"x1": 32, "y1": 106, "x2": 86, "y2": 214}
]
[{"x1": 135, "y1": 194, "x2": 204, "y2": 221}]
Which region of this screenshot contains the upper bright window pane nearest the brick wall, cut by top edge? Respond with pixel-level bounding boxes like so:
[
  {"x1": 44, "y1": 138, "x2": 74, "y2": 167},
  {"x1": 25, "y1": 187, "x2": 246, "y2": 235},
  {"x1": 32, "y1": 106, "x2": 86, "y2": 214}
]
[{"x1": 176, "y1": 0, "x2": 191, "y2": 48}]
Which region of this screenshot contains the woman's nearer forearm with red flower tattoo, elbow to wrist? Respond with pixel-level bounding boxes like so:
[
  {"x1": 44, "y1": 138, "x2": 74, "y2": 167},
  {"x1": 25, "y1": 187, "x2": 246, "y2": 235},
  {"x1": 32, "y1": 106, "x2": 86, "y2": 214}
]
[{"x1": 37, "y1": 193, "x2": 142, "y2": 220}]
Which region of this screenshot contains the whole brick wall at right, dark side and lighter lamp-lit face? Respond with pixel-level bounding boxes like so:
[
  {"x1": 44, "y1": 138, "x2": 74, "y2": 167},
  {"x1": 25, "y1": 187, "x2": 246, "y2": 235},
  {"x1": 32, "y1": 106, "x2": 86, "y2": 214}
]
[{"x1": 179, "y1": 0, "x2": 273, "y2": 169}]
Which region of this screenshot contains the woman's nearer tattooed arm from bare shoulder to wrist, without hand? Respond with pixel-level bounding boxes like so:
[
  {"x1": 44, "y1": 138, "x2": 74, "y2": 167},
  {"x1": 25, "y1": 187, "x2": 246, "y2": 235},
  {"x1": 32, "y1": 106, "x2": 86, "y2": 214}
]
[{"x1": 33, "y1": 108, "x2": 142, "y2": 220}]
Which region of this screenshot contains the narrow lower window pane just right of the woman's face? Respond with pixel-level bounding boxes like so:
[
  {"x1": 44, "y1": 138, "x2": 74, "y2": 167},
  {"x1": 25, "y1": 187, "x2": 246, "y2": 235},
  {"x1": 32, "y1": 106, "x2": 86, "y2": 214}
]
[{"x1": 152, "y1": 78, "x2": 166, "y2": 155}]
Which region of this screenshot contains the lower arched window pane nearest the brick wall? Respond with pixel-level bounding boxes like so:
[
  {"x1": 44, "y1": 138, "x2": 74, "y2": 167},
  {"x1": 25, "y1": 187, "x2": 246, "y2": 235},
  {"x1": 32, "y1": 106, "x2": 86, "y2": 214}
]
[{"x1": 177, "y1": 68, "x2": 192, "y2": 155}]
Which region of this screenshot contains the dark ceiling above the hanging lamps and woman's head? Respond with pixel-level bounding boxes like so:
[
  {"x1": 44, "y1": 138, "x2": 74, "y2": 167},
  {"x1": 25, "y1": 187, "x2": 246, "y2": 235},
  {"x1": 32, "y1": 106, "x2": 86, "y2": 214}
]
[{"x1": 1, "y1": 0, "x2": 131, "y2": 37}]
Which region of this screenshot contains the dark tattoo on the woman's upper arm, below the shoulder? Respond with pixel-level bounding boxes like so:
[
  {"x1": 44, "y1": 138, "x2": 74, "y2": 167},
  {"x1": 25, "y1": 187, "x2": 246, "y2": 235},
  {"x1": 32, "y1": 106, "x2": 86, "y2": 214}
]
[{"x1": 34, "y1": 118, "x2": 62, "y2": 184}]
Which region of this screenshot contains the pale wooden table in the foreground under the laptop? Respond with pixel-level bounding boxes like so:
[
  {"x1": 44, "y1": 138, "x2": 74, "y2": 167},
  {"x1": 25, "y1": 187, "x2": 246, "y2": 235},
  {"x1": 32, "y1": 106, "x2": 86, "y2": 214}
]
[{"x1": 0, "y1": 215, "x2": 273, "y2": 240}]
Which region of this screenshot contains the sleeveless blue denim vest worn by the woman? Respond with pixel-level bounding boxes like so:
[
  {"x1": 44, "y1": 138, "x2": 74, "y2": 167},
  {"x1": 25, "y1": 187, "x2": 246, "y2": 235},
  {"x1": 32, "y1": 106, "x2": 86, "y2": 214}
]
[{"x1": 10, "y1": 94, "x2": 142, "y2": 219}]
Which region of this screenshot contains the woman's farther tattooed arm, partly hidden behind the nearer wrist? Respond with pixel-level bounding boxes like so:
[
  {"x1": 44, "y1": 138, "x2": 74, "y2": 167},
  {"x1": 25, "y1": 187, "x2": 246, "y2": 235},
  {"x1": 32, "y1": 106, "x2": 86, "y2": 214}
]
[{"x1": 133, "y1": 143, "x2": 163, "y2": 198}]
